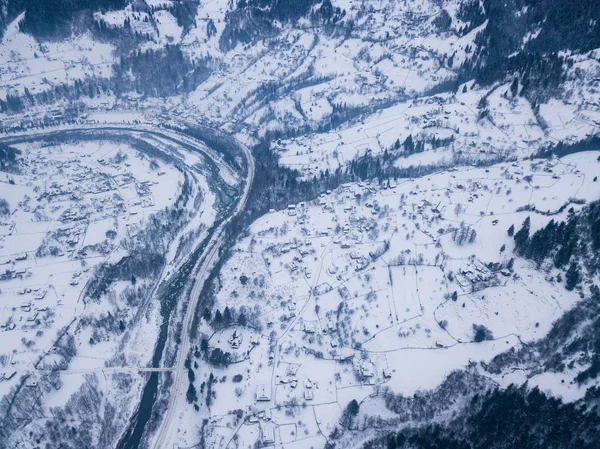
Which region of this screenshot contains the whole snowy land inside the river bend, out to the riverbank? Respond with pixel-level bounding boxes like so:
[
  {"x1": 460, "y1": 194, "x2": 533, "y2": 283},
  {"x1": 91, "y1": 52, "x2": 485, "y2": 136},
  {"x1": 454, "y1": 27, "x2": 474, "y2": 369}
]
[{"x1": 0, "y1": 128, "x2": 238, "y2": 444}]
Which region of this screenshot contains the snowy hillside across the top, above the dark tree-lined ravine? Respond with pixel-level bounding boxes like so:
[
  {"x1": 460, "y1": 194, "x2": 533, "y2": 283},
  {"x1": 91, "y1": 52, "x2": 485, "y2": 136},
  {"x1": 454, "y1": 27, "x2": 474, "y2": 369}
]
[{"x1": 0, "y1": 0, "x2": 600, "y2": 176}]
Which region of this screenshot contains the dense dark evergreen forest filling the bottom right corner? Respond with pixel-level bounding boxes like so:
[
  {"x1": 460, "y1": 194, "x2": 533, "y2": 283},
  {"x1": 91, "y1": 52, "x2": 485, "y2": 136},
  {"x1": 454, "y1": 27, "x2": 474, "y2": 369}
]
[{"x1": 363, "y1": 384, "x2": 600, "y2": 449}]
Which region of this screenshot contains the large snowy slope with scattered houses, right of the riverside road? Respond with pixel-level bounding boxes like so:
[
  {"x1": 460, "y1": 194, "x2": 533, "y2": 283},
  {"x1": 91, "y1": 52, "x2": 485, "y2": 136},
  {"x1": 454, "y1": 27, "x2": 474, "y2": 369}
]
[{"x1": 170, "y1": 152, "x2": 600, "y2": 448}]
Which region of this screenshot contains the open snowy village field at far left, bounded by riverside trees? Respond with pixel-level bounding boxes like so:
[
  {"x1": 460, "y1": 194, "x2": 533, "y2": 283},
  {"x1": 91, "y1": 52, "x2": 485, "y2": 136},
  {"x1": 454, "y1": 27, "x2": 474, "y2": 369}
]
[{"x1": 0, "y1": 137, "x2": 176, "y2": 374}]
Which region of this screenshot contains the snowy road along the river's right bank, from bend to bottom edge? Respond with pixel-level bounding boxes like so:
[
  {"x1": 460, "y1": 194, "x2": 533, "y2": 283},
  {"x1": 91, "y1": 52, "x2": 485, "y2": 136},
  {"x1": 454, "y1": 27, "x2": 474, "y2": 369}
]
[{"x1": 152, "y1": 131, "x2": 254, "y2": 449}]
